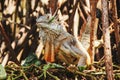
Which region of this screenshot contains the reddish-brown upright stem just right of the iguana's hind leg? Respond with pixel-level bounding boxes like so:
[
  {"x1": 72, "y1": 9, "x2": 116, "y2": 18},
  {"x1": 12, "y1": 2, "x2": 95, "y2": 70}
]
[{"x1": 89, "y1": 0, "x2": 97, "y2": 67}]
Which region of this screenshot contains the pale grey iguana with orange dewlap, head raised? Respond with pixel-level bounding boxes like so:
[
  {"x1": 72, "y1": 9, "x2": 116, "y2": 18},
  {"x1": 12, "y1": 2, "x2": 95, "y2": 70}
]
[{"x1": 36, "y1": 14, "x2": 90, "y2": 66}]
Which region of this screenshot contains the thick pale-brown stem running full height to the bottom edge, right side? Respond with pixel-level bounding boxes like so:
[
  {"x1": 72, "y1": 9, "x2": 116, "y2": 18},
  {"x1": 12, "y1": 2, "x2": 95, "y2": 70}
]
[{"x1": 101, "y1": 0, "x2": 113, "y2": 80}]
